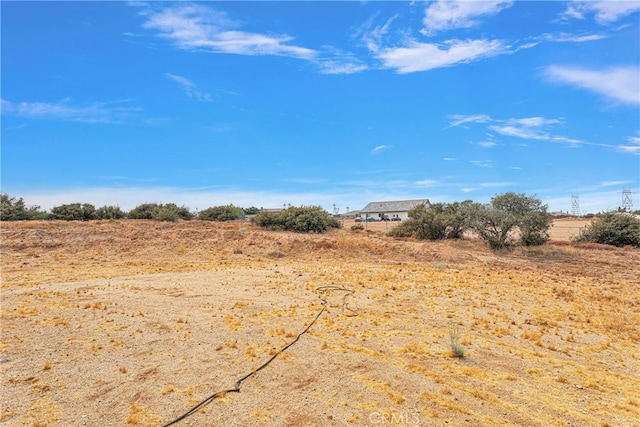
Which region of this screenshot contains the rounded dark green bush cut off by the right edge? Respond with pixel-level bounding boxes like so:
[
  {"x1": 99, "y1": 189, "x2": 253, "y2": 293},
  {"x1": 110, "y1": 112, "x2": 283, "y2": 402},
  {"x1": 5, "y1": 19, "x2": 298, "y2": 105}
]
[{"x1": 574, "y1": 212, "x2": 640, "y2": 247}]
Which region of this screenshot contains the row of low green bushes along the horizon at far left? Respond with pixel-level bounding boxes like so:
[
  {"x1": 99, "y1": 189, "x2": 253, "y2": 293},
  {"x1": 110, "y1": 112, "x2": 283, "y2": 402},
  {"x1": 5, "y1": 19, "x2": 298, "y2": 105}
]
[{"x1": 0, "y1": 194, "x2": 259, "y2": 221}]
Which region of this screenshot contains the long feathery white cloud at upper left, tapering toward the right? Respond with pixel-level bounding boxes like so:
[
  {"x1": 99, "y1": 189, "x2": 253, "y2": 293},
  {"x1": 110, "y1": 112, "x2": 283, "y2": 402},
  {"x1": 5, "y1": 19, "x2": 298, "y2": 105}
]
[{"x1": 141, "y1": 4, "x2": 317, "y2": 60}]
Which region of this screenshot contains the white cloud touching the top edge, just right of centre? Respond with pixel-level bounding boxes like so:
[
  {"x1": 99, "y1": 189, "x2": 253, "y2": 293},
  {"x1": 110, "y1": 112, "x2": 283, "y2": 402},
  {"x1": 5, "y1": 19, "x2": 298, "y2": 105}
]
[{"x1": 423, "y1": 0, "x2": 513, "y2": 35}]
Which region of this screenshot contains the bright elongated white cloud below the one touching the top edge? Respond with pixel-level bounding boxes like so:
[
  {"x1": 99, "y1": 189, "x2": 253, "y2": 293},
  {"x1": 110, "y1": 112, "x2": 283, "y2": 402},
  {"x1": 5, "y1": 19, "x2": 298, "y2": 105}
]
[{"x1": 376, "y1": 40, "x2": 505, "y2": 74}]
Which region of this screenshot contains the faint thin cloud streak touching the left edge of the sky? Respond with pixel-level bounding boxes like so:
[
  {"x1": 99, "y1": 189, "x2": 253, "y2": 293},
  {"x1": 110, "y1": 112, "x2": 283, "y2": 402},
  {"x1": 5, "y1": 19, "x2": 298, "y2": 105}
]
[{"x1": 0, "y1": 99, "x2": 142, "y2": 124}]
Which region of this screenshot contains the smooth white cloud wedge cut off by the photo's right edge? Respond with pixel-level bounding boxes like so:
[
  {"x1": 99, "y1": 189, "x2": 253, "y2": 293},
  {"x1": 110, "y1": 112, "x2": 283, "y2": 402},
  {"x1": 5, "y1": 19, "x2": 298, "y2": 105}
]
[{"x1": 545, "y1": 65, "x2": 640, "y2": 104}]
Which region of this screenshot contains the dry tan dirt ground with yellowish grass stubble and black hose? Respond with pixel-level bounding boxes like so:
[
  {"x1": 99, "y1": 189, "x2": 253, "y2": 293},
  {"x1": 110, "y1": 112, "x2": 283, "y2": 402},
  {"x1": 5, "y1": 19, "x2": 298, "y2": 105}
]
[{"x1": 0, "y1": 221, "x2": 640, "y2": 427}]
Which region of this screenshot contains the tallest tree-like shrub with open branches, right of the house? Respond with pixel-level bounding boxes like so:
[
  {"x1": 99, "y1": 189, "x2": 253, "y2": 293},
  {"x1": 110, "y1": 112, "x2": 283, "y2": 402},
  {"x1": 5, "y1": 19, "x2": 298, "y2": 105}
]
[{"x1": 466, "y1": 193, "x2": 552, "y2": 249}]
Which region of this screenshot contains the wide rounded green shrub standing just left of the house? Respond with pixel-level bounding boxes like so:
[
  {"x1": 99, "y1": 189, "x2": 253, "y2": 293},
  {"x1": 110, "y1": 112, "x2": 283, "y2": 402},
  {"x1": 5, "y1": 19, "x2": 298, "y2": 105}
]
[{"x1": 253, "y1": 206, "x2": 341, "y2": 233}]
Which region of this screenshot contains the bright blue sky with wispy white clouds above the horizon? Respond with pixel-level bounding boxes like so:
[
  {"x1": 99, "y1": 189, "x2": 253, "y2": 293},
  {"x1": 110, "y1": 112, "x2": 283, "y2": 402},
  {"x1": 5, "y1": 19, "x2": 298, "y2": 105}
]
[{"x1": 0, "y1": 1, "x2": 640, "y2": 212}]
